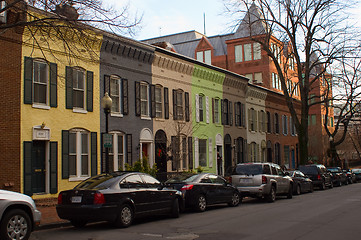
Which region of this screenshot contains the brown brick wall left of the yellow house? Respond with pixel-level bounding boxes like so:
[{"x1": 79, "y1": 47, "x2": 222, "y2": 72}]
[{"x1": 0, "y1": 12, "x2": 22, "y2": 192}]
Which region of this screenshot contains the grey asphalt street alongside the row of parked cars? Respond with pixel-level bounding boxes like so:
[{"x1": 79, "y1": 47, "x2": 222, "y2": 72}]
[{"x1": 30, "y1": 183, "x2": 361, "y2": 240}]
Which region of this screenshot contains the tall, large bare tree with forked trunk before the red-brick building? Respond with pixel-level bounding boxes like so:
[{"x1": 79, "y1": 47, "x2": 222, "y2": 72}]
[{"x1": 224, "y1": 0, "x2": 360, "y2": 164}]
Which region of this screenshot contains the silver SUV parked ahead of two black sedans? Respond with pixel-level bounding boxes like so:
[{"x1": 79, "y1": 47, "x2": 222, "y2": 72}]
[{"x1": 232, "y1": 163, "x2": 293, "y2": 202}]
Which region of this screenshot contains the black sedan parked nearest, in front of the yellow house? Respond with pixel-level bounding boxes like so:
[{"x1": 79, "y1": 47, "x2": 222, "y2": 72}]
[{"x1": 56, "y1": 172, "x2": 184, "y2": 227}]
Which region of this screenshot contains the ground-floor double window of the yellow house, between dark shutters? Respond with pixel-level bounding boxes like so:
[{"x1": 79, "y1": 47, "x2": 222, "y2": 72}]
[{"x1": 69, "y1": 130, "x2": 90, "y2": 177}]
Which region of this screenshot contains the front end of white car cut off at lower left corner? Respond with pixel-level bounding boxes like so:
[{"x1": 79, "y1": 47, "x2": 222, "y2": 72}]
[{"x1": 0, "y1": 190, "x2": 41, "y2": 240}]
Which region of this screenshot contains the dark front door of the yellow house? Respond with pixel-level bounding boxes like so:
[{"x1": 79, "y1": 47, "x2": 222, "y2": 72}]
[{"x1": 31, "y1": 141, "x2": 46, "y2": 193}]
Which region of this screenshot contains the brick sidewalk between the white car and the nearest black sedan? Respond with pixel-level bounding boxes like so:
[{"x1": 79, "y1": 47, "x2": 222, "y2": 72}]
[{"x1": 35, "y1": 199, "x2": 70, "y2": 230}]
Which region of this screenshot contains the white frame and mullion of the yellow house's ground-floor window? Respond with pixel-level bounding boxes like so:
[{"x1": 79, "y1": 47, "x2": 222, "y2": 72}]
[{"x1": 69, "y1": 129, "x2": 91, "y2": 181}]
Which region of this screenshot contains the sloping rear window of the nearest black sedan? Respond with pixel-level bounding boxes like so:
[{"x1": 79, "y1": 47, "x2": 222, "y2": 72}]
[{"x1": 74, "y1": 174, "x2": 119, "y2": 190}]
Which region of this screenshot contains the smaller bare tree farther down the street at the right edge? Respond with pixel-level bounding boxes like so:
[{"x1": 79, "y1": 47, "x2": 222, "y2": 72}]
[{"x1": 324, "y1": 51, "x2": 361, "y2": 166}]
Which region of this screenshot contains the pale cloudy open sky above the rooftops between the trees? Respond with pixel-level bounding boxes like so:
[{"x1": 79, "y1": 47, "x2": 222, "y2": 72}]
[{"x1": 104, "y1": 0, "x2": 361, "y2": 40}]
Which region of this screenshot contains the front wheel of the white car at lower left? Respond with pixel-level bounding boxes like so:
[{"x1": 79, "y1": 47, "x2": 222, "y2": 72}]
[{"x1": 0, "y1": 209, "x2": 32, "y2": 240}]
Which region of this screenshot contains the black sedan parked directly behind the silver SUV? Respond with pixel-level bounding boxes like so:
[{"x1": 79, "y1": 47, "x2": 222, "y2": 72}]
[{"x1": 166, "y1": 173, "x2": 242, "y2": 212}]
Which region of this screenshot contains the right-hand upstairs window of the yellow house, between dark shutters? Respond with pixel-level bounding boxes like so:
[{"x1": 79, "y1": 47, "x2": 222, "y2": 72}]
[{"x1": 73, "y1": 68, "x2": 86, "y2": 109}]
